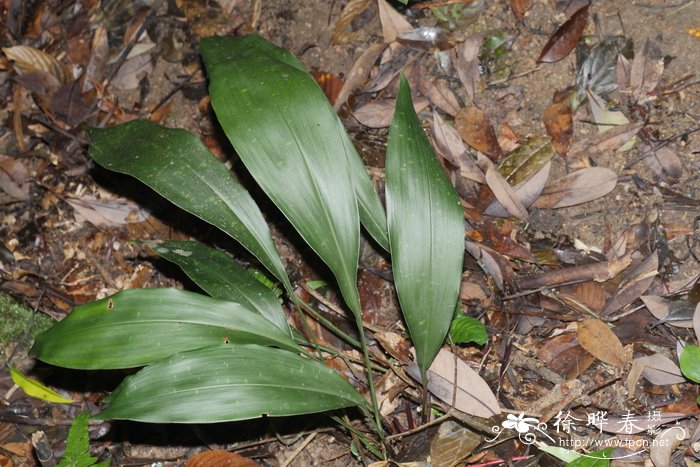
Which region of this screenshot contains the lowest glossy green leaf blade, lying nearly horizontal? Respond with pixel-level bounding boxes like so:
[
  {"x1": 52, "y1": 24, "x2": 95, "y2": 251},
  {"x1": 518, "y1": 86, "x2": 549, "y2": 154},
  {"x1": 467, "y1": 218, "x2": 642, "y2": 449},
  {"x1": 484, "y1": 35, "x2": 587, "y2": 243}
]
[{"x1": 99, "y1": 345, "x2": 367, "y2": 423}]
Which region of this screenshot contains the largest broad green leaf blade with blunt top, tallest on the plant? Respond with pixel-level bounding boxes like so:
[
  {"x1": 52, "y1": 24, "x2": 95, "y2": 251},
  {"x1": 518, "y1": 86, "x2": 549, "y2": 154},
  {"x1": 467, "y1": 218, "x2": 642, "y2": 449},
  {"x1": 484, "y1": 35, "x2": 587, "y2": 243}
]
[{"x1": 201, "y1": 36, "x2": 386, "y2": 315}]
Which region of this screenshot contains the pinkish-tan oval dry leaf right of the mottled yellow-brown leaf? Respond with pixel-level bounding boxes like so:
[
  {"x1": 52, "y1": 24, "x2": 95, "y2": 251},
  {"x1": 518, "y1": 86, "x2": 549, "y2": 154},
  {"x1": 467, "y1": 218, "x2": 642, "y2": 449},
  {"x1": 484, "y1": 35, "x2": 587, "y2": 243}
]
[{"x1": 533, "y1": 167, "x2": 617, "y2": 209}]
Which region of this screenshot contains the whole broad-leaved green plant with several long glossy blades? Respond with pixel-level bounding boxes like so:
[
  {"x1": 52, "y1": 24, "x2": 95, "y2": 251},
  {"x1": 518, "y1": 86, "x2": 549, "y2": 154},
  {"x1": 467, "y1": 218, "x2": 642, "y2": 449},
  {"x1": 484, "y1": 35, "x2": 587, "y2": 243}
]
[{"x1": 32, "y1": 36, "x2": 484, "y2": 456}]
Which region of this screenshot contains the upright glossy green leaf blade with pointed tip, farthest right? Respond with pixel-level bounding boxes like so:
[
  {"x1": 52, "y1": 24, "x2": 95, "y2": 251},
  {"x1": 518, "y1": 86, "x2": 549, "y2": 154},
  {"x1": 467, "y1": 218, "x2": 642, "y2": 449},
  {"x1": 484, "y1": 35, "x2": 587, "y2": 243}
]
[{"x1": 386, "y1": 77, "x2": 464, "y2": 381}]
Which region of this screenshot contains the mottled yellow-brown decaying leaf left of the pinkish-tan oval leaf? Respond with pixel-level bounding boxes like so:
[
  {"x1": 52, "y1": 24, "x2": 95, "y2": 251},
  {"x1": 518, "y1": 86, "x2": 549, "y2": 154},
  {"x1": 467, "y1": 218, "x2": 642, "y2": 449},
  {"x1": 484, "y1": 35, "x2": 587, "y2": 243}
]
[{"x1": 498, "y1": 136, "x2": 554, "y2": 186}]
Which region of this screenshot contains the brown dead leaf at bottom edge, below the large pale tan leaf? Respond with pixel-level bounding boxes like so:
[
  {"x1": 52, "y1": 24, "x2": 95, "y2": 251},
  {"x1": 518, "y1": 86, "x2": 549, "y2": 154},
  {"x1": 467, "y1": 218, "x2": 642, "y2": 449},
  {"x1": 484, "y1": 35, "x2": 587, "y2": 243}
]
[{"x1": 430, "y1": 420, "x2": 483, "y2": 467}]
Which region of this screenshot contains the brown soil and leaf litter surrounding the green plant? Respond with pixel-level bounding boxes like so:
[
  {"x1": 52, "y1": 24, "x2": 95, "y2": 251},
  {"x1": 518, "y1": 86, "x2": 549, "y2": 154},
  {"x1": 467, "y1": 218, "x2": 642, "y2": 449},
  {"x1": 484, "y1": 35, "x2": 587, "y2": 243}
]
[{"x1": 0, "y1": 0, "x2": 700, "y2": 467}]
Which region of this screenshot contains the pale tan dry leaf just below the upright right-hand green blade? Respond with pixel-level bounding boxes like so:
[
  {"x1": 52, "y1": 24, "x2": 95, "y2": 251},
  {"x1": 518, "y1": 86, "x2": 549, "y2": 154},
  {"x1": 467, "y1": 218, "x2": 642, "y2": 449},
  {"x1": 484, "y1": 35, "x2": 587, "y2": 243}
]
[{"x1": 406, "y1": 349, "x2": 501, "y2": 418}]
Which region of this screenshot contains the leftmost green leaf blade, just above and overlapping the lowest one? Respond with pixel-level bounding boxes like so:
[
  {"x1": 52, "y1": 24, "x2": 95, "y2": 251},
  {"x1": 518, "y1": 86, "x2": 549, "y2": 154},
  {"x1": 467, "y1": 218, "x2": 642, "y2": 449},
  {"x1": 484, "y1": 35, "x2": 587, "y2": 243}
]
[{"x1": 31, "y1": 289, "x2": 298, "y2": 369}]
